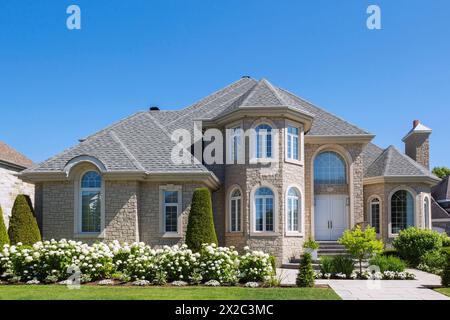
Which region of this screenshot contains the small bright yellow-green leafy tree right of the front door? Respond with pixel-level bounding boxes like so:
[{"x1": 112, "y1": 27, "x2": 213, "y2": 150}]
[{"x1": 338, "y1": 226, "x2": 384, "y2": 273}]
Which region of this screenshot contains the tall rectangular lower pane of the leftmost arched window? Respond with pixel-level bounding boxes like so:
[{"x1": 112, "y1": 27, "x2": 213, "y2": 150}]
[{"x1": 81, "y1": 191, "x2": 101, "y2": 232}]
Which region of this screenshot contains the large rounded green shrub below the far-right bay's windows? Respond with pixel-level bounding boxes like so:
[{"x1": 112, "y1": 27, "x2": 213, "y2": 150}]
[{"x1": 393, "y1": 227, "x2": 442, "y2": 267}]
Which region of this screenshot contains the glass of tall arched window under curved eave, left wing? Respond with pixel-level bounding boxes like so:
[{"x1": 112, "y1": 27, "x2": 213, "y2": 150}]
[{"x1": 80, "y1": 171, "x2": 102, "y2": 233}]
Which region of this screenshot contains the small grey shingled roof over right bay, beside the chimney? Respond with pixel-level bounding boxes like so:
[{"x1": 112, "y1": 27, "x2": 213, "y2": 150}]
[{"x1": 365, "y1": 146, "x2": 439, "y2": 180}]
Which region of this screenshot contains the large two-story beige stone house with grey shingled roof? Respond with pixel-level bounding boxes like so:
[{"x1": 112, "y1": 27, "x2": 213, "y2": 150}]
[{"x1": 22, "y1": 77, "x2": 439, "y2": 262}]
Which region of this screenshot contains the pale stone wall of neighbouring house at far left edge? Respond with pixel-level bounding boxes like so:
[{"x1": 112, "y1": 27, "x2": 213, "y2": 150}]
[{"x1": 0, "y1": 165, "x2": 34, "y2": 227}]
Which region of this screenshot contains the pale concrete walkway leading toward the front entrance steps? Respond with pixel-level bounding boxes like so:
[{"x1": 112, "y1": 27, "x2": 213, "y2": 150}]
[{"x1": 278, "y1": 269, "x2": 450, "y2": 300}]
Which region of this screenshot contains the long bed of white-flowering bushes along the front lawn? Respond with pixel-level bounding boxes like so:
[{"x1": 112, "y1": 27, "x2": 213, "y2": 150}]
[{"x1": 0, "y1": 240, "x2": 275, "y2": 286}]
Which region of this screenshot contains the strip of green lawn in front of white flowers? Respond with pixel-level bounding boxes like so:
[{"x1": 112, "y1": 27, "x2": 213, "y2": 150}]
[{"x1": 0, "y1": 285, "x2": 340, "y2": 300}]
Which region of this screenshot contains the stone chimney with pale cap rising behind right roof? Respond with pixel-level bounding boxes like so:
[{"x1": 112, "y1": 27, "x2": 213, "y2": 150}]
[{"x1": 402, "y1": 120, "x2": 432, "y2": 169}]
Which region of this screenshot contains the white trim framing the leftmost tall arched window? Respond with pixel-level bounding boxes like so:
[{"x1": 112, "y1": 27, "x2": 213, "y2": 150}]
[{"x1": 74, "y1": 168, "x2": 105, "y2": 239}]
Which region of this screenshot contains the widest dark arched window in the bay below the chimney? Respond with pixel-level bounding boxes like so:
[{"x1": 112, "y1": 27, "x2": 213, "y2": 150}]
[{"x1": 391, "y1": 190, "x2": 414, "y2": 234}]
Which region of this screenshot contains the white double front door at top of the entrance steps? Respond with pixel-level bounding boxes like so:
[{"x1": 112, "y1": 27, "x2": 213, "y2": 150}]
[{"x1": 314, "y1": 195, "x2": 348, "y2": 241}]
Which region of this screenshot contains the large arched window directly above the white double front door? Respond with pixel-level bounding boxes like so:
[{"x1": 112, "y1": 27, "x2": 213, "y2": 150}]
[{"x1": 314, "y1": 151, "x2": 347, "y2": 184}]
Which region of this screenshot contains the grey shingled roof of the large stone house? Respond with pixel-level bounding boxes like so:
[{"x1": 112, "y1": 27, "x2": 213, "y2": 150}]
[{"x1": 26, "y1": 78, "x2": 430, "y2": 177}]
